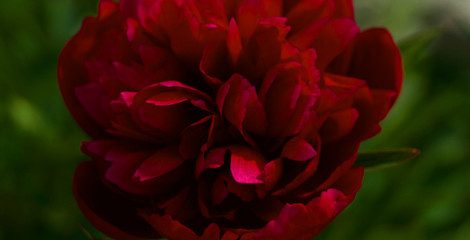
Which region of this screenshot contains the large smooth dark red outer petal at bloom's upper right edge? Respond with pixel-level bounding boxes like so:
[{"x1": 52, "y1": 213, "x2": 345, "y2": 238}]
[{"x1": 327, "y1": 28, "x2": 403, "y2": 100}]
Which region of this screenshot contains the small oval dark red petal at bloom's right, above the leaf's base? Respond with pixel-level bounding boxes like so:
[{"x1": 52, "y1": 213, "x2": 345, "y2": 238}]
[{"x1": 320, "y1": 108, "x2": 359, "y2": 143}]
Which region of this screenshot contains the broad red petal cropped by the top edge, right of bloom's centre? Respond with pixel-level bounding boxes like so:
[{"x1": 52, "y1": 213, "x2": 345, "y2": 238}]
[{"x1": 286, "y1": 0, "x2": 334, "y2": 34}]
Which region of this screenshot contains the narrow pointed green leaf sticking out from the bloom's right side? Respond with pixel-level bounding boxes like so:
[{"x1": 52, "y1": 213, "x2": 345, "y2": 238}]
[{"x1": 354, "y1": 148, "x2": 420, "y2": 170}]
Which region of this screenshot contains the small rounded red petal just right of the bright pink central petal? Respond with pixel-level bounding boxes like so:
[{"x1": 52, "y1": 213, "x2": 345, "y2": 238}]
[{"x1": 281, "y1": 136, "x2": 317, "y2": 161}]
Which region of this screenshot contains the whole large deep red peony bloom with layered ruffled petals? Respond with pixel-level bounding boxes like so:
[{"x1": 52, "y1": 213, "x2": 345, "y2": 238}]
[{"x1": 58, "y1": 0, "x2": 402, "y2": 240}]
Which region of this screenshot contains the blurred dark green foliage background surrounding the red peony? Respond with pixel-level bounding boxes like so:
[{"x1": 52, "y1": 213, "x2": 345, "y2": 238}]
[{"x1": 0, "y1": 0, "x2": 470, "y2": 240}]
